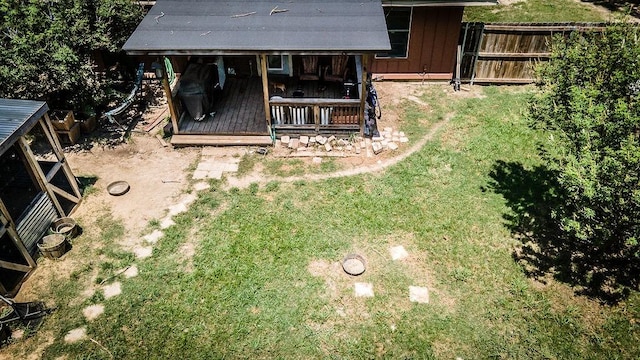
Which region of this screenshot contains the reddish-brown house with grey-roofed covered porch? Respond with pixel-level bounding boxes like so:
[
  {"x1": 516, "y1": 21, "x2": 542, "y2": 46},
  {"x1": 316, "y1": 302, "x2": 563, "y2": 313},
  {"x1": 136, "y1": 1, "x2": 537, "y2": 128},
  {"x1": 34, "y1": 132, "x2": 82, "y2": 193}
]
[{"x1": 123, "y1": 0, "x2": 495, "y2": 145}]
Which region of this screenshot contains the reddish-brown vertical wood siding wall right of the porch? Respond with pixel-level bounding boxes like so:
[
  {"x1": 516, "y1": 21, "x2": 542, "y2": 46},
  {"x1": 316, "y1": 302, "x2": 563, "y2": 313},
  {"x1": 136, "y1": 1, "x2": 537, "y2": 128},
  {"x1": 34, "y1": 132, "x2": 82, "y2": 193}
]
[{"x1": 371, "y1": 7, "x2": 464, "y2": 79}]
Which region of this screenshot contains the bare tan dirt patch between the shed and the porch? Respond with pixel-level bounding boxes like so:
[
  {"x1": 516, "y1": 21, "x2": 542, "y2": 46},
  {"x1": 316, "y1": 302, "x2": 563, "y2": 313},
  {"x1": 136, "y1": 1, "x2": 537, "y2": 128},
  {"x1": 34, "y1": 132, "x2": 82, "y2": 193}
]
[{"x1": 67, "y1": 134, "x2": 200, "y2": 235}]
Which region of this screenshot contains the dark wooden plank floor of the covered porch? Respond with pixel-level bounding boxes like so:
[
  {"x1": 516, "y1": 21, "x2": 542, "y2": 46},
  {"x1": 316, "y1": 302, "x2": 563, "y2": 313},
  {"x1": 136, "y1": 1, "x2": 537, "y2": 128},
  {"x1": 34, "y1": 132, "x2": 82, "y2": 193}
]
[{"x1": 178, "y1": 77, "x2": 268, "y2": 135}]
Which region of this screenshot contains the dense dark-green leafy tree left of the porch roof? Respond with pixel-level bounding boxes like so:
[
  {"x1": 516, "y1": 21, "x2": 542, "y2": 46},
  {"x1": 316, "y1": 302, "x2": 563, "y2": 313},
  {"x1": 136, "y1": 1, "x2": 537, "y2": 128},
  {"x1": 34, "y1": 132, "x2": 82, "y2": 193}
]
[{"x1": 0, "y1": 0, "x2": 142, "y2": 108}]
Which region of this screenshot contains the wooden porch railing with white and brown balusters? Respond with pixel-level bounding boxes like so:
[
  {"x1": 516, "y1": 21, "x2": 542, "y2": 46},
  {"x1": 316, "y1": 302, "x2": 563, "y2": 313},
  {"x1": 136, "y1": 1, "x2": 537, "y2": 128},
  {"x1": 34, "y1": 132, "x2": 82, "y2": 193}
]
[{"x1": 269, "y1": 98, "x2": 360, "y2": 132}]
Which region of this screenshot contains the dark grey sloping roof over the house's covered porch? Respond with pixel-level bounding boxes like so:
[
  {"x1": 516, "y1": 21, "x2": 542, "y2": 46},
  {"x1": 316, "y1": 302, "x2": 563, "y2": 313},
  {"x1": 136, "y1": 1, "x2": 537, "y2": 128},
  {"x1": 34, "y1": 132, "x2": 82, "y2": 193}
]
[{"x1": 123, "y1": 0, "x2": 391, "y2": 55}]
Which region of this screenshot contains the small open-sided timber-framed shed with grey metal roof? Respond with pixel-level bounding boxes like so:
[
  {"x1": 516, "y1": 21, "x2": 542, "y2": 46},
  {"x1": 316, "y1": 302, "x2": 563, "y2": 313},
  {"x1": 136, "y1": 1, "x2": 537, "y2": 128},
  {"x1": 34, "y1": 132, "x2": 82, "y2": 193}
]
[{"x1": 0, "y1": 99, "x2": 81, "y2": 295}]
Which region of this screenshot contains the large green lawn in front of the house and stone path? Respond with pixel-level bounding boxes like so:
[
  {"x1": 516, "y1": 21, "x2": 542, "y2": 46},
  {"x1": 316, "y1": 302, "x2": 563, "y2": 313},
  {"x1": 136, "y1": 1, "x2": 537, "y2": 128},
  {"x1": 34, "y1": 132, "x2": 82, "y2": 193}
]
[{"x1": 10, "y1": 85, "x2": 640, "y2": 359}]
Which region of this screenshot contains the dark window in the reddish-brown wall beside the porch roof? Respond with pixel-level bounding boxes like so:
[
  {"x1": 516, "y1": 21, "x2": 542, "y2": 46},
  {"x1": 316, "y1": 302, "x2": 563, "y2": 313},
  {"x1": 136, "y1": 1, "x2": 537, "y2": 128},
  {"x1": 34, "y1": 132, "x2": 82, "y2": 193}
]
[{"x1": 376, "y1": 7, "x2": 412, "y2": 58}]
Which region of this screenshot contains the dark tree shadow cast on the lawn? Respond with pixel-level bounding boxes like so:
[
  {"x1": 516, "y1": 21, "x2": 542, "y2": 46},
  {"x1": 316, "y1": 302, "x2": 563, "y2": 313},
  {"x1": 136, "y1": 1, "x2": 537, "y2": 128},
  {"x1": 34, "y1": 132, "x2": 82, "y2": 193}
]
[{"x1": 488, "y1": 161, "x2": 640, "y2": 304}]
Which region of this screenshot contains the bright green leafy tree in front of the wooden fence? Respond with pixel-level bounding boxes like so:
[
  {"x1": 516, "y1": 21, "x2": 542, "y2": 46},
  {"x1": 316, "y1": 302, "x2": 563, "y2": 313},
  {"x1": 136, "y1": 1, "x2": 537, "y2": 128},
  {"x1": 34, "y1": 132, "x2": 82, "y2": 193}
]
[{"x1": 531, "y1": 24, "x2": 640, "y2": 293}]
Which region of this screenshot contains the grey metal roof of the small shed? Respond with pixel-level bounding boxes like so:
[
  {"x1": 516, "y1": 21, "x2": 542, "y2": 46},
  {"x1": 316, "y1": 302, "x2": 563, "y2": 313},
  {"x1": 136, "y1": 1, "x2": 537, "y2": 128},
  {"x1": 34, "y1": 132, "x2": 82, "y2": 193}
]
[{"x1": 0, "y1": 99, "x2": 49, "y2": 155}]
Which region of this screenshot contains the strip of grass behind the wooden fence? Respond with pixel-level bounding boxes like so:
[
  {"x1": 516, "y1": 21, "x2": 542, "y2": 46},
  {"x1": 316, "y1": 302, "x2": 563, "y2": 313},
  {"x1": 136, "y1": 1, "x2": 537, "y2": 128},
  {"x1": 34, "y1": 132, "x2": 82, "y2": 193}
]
[{"x1": 464, "y1": 0, "x2": 621, "y2": 22}]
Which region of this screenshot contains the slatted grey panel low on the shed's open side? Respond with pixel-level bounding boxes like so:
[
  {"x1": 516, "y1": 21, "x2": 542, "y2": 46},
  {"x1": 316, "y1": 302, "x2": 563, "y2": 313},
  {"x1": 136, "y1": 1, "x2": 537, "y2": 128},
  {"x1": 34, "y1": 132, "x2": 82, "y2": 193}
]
[{"x1": 16, "y1": 193, "x2": 58, "y2": 255}]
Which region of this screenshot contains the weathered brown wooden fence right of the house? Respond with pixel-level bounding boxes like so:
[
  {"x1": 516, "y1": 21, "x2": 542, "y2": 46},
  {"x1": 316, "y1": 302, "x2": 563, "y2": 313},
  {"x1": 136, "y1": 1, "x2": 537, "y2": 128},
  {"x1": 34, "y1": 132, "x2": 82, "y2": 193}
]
[{"x1": 459, "y1": 23, "x2": 605, "y2": 84}]
